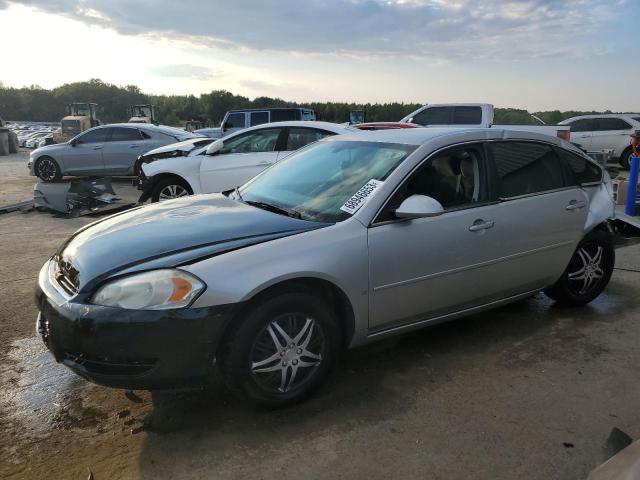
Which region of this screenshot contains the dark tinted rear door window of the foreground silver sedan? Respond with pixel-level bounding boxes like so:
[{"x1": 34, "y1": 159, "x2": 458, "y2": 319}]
[{"x1": 488, "y1": 142, "x2": 565, "y2": 199}]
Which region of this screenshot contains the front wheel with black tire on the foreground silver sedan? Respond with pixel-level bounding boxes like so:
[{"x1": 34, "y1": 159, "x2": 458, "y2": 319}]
[{"x1": 218, "y1": 293, "x2": 341, "y2": 408}]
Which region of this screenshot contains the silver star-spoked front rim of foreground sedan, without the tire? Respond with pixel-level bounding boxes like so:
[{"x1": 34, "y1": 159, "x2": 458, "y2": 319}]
[{"x1": 250, "y1": 314, "x2": 326, "y2": 393}]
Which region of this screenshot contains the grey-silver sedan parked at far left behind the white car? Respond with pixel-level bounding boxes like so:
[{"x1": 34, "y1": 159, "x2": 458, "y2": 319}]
[{"x1": 28, "y1": 123, "x2": 199, "y2": 182}]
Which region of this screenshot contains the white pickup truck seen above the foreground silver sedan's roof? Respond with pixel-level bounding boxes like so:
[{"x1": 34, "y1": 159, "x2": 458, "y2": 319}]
[{"x1": 400, "y1": 103, "x2": 571, "y2": 142}]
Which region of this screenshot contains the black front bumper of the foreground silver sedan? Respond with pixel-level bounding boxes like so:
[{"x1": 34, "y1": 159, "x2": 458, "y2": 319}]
[{"x1": 36, "y1": 263, "x2": 237, "y2": 390}]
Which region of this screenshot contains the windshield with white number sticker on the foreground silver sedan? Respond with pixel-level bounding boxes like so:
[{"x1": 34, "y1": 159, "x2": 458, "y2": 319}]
[{"x1": 239, "y1": 140, "x2": 416, "y2": 222}]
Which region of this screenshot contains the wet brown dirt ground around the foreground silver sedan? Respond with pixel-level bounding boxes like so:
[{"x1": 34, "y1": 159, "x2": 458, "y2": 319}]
[{"x1": 0, "y1": 155, "x2": 640, "y2": 480}]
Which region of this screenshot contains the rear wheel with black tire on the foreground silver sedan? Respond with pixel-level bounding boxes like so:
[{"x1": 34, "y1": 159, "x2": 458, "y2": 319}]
[{"x1": 544, "y1": 230, "x2": 616, "y2": 305}]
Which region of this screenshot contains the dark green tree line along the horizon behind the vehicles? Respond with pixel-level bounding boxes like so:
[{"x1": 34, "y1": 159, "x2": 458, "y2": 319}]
[{"x1": 0, "y1": 79, "x2": 610, "y2": 126}]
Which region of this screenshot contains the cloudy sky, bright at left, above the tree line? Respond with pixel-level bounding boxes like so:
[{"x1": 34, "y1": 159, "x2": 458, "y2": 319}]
[{"x1": 0, "y1": 0, "x2": 640, "y2": 111}]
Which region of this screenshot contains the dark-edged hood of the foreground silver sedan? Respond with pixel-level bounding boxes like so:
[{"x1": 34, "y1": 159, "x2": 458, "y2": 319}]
[{"x1": 54, "y1": 194, "x2": 331, "y2": 293}]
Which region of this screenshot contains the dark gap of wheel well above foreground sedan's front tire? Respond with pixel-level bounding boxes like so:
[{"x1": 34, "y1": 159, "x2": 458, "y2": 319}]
[{"x1": 223, "y1": 277, "x2": 355, "y2": 348}]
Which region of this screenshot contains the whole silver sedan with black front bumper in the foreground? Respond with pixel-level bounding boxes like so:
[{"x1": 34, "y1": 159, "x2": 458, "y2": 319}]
[{"x1": 36, "y1": 128, "x2": 615, "y2": 407}]
